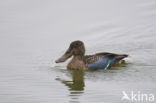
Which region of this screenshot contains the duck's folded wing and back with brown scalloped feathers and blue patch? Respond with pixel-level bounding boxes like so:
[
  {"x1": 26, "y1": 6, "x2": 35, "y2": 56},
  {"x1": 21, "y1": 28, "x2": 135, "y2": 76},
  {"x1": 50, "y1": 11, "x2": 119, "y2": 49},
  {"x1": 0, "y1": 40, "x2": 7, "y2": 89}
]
[{"x1": 85, "y1": 52, "x2": 128, "y2": 69}]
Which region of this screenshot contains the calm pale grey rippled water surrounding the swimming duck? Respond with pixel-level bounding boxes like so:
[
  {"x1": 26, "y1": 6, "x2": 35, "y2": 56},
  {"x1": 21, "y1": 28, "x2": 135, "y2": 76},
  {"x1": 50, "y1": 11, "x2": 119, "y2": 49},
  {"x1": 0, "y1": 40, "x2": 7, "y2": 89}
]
[{"x1": 0, "y1": 0, "x2": 156, "y2": 103}]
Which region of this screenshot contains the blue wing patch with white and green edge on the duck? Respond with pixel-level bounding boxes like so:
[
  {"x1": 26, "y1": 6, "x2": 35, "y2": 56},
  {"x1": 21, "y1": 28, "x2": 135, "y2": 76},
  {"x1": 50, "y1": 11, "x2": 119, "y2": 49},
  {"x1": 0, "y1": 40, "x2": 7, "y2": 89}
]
[{"x1": 88, "y1": 57, "x2": 114, "y2": 70}]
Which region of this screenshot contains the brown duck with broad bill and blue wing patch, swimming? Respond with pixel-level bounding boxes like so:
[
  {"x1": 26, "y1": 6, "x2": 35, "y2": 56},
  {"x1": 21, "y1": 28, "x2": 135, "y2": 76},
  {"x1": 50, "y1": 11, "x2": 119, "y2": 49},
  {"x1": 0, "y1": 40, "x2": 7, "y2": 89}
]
[{"x1": 55, "y1": 40, "x2": 128, "y2": 70}]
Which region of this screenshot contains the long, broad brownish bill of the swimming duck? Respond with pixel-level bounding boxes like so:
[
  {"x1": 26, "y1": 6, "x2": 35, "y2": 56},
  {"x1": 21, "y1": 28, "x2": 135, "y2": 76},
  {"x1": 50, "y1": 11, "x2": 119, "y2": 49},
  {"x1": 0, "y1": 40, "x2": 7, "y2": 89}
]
[{"x1": 55, "y1": 49, "x2": 72, "y2": 63}]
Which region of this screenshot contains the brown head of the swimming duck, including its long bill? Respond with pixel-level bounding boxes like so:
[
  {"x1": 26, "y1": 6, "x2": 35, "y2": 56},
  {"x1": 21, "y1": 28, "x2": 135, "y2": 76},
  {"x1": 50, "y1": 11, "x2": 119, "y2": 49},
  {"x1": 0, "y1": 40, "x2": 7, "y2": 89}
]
[{"x1": 55, "y1": 40, "x2": 85, "y2": 63}]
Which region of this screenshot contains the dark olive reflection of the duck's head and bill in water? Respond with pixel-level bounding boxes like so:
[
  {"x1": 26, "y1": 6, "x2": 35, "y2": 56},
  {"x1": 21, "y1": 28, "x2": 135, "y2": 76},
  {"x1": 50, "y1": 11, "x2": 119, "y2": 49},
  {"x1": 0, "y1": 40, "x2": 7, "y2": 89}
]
[{"x1": 57, "y1": 70, "x2": 85, "y2": 91}]
